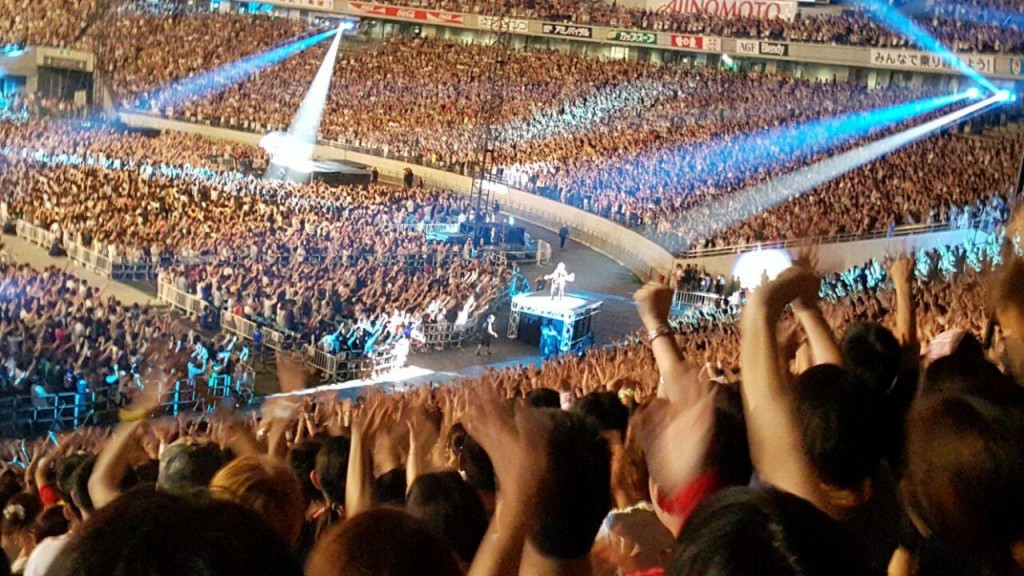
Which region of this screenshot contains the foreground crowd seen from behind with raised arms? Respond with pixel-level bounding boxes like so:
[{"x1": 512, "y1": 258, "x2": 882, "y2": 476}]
[{"x1": 0, "y1": 208, "x2": 1024, "y2": 576}]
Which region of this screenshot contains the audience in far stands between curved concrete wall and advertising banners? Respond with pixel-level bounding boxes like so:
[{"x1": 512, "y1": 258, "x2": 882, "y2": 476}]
[{"x1": 123, "y1": 37, "x2": 1022, "y2": 252}]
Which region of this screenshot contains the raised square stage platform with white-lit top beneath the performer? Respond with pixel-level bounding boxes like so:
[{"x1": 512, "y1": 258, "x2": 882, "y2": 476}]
[{"x1": 508, "y1": 291, "x2": 602, "y2": 356}]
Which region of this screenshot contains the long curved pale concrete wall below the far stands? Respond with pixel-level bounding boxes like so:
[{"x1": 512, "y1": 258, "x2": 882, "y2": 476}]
[{"x1": 121, "y1": 113, "x2": 673, "y2": 280}]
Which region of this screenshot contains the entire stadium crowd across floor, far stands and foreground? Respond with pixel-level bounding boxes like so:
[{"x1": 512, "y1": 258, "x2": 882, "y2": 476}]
[{"x1": 0, "y1": 5, "x2": 1024, "y2": 576}]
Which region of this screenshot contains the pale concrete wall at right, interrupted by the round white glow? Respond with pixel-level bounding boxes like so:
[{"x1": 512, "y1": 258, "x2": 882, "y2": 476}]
[{"x1": 676, "y1": 230, "x2": 988, "y2": 276}]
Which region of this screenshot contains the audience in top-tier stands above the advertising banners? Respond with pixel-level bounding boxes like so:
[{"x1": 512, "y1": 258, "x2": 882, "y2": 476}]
[{"x1": 6, "y1": 0, "x2": 1024, "y2": 54}]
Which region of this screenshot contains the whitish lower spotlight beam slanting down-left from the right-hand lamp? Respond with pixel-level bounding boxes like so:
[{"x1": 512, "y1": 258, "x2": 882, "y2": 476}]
[{"x1": 687, "y1": 94, "x2": 1007, "y2": 239}]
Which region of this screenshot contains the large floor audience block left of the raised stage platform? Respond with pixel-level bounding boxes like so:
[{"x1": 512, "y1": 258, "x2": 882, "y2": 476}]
[{"x1": 0, "y1": 121, "x2": 510, "y2": 353}]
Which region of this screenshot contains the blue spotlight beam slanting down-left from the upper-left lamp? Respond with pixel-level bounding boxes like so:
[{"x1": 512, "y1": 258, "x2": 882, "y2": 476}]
[{"x1": 141, "y1": 30, "x2": 334, "y2": 111}]
